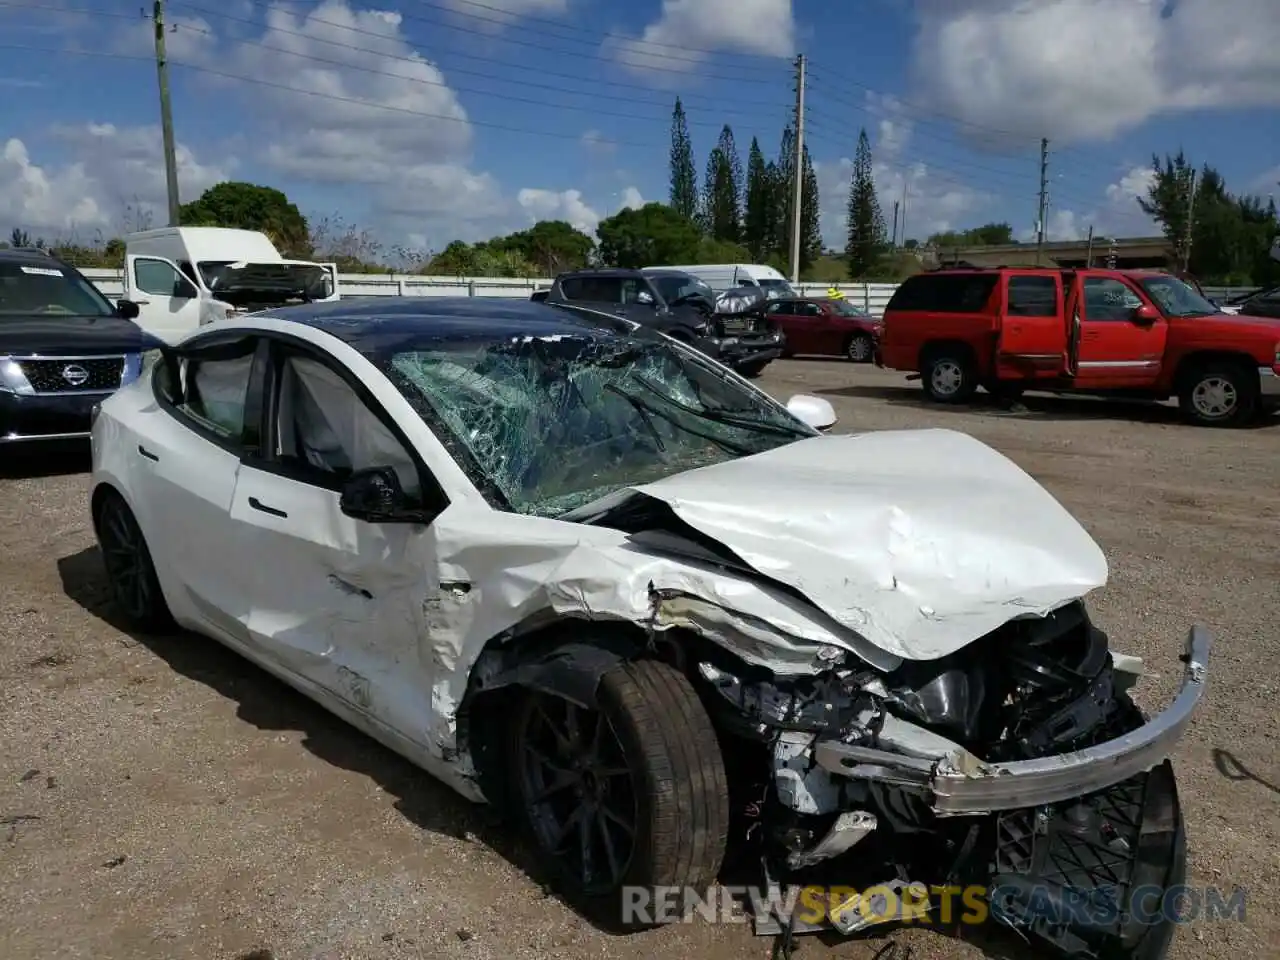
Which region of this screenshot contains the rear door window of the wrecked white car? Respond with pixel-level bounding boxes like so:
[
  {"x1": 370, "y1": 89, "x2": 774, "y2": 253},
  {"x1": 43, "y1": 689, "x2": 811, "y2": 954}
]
[{"x1": 156, "y1": 337, "x2": 259, "y2": 444}]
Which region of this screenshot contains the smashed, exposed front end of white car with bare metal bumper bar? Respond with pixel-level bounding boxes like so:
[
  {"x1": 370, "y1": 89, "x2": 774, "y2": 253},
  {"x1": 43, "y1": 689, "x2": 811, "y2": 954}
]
[{"x1": 698, "y1": 603, "x2": 1208, "y2": 956}]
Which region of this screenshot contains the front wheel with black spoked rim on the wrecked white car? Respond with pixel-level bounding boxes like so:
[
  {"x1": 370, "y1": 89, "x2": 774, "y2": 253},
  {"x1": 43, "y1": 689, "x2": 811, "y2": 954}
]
[{"x1": 508, "y1": 660, "x2": 730, "y2": 929}]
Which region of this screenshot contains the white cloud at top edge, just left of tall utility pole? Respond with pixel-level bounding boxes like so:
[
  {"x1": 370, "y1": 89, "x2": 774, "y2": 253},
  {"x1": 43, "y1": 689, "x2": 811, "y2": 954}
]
[{"x1": 604, "y1": 0, "x2": 796, "y2": 76}]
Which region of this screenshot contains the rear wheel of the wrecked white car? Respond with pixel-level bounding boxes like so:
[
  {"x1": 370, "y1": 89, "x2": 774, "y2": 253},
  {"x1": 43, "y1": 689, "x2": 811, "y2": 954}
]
[{"x1": 93, "y1": 490, "x2": 173, "y2": 634}]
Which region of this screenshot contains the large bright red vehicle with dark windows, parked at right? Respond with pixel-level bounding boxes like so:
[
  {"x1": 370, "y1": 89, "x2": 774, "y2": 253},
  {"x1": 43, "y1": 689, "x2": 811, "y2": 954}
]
[{"x1": 877, "y1": 268, "x2": 1280, "y2": 426}]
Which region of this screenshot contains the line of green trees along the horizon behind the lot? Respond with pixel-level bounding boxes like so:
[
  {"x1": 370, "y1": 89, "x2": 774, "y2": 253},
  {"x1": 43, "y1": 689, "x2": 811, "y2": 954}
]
[{"x1": 0, "y1": 138, "x2": 1280, "y2": 287}]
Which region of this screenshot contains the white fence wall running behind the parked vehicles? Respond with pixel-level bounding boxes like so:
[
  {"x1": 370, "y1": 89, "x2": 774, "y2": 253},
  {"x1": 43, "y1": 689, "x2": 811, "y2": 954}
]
[{"x1": 82, "y1": 270, "x2": 1247, "y2": 316}]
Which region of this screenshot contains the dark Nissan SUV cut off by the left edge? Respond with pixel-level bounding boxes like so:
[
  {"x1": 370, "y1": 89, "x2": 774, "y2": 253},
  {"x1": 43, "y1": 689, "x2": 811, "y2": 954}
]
[{"x1": 0, "y1": 248, "x2": 161, "y2": 447}]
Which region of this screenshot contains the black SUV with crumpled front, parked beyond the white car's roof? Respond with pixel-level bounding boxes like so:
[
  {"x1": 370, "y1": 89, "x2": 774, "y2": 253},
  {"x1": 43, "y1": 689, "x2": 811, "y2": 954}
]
[{"x1": 532, "y1": 269, "x2": 785, "y2": 376}]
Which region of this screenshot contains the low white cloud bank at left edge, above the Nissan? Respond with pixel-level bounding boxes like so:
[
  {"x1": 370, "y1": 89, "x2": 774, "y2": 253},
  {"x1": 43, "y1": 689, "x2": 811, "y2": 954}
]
[{"x1": 0, "y1": 123, "x2": 237, "y2": 242}]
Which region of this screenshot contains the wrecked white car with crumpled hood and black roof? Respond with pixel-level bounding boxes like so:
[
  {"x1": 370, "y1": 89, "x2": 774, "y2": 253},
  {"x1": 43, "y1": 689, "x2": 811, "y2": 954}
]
[{"x1": 92, "y1": 298, "x2": 1208, "y2": 960}]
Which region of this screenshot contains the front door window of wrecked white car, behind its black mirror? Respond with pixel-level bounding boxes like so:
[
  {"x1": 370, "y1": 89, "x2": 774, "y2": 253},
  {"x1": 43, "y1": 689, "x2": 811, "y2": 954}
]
[{"x1": 273, "y1": 348, "x2": 422, "y2": 499}]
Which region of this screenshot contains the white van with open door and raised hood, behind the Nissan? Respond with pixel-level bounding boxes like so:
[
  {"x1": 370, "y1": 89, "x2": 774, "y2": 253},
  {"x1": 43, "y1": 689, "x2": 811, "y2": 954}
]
[{"x1": 124, "y1": 227, "x2": 339, "y2": 343}]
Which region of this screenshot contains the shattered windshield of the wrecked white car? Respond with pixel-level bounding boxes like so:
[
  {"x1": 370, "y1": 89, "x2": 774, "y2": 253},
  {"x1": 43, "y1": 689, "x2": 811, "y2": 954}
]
[{"x1": 372, "y1": 335, "x2": 815, "y2": 517}]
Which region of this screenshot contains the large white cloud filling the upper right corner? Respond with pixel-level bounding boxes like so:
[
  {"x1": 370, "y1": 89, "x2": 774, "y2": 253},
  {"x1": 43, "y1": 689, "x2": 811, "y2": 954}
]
[{"x1": 913, "y1": 0, "x2": 1280, "y2": 146}]
